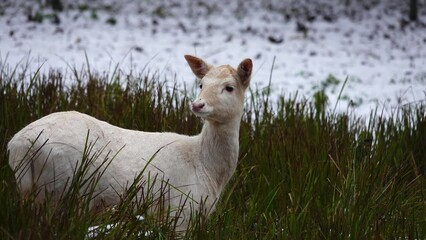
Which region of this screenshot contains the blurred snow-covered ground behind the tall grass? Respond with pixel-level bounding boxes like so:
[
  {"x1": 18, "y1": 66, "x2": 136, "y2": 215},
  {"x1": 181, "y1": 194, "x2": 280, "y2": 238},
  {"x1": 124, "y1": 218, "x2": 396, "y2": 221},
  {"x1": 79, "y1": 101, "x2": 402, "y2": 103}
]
[{"x1": 0, "y1": 0, "x2": 426, "y2": 115}]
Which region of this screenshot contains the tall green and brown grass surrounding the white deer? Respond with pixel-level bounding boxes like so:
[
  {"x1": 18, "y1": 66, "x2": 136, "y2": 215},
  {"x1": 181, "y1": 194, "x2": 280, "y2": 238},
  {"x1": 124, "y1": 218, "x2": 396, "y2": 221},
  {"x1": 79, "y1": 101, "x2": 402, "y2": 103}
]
[{"x1": 0, "y1": 64, "x2": 426, "y2": 239}]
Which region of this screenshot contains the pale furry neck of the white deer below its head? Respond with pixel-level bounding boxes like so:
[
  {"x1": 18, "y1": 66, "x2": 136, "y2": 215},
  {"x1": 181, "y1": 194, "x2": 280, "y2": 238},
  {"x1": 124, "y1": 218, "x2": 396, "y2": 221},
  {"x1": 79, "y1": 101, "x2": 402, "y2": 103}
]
[{"x1": 200, "y1": 119, "x2": 241, "y2": 193}]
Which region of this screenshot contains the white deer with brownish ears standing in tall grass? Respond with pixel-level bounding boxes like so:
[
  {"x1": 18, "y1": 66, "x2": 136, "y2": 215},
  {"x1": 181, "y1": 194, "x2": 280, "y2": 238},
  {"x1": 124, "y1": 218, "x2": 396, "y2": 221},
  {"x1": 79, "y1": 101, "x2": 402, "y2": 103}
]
[{"x1": 8, "y1": 55, "x2": 252, "y2": 229}]
